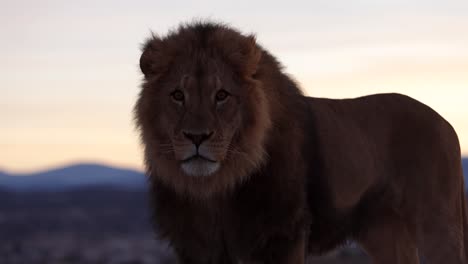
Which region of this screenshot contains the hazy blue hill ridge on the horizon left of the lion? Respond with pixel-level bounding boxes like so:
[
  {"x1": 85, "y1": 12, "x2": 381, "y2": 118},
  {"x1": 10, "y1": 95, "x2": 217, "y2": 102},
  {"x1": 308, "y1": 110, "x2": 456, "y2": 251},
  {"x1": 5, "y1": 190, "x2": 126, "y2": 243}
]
[{"x1": 0, "y1": 164, "x2": 146, "y2": 191}]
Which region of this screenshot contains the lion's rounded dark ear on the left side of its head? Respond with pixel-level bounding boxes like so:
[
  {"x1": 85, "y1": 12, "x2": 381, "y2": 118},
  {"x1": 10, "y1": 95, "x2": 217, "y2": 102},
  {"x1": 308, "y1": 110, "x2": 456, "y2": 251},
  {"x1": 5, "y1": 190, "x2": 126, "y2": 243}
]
[{"x1": 140, "y1": 34, "x2": 167, "y2": 78}]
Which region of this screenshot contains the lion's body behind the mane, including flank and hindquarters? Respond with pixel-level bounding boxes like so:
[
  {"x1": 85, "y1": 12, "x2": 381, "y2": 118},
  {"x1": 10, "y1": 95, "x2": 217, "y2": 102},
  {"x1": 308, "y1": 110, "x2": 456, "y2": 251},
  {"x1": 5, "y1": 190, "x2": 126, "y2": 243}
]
[{"x1": 308, "y1": 94, "x2": 466, "y2": 263}]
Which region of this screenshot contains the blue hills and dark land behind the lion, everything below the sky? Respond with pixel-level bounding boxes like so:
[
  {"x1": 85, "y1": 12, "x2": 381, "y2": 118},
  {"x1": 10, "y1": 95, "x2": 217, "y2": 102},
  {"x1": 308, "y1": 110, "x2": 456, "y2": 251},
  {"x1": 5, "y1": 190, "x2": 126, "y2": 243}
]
[{"x1": 0, "y1": 159, "x2": 468, "y2": 264}]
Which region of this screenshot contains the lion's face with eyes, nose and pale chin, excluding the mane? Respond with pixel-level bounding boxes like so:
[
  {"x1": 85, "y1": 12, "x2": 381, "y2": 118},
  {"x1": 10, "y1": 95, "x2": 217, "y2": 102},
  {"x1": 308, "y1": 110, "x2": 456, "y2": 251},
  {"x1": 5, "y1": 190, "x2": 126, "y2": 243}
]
[{"x1": 150, "y1": 61, "x2": 246, "y2": 177}]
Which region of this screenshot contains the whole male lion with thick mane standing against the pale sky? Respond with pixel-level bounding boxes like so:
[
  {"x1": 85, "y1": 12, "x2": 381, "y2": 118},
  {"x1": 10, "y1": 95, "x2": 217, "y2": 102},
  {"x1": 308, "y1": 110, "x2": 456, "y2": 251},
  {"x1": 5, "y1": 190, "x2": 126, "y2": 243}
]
[{"x1": 135, "y1": 22, "x2": 468, "y2": 264}]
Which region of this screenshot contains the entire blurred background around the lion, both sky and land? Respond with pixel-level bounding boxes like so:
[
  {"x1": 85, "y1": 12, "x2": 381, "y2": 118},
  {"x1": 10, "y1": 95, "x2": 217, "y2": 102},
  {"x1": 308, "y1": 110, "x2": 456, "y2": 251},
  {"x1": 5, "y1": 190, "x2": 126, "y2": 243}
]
[{"x1": 0, "y1": 0, "x2": 468, "y2": 264}]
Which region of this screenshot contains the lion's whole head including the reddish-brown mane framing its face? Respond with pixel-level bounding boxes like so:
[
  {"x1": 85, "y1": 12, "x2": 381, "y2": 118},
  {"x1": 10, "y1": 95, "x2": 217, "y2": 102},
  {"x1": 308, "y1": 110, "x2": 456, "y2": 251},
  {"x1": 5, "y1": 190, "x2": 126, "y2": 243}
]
[{"x1": 135, "y1": 23, "x2": 271, "y2": 195}]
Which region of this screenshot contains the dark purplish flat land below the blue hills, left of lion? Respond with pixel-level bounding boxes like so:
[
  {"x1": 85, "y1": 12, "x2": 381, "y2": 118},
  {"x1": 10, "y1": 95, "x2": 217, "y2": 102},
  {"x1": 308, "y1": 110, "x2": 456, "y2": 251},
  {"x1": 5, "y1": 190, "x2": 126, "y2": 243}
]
[{"x1": 0, "y1": 186, "x2": 172, "y2": 264}]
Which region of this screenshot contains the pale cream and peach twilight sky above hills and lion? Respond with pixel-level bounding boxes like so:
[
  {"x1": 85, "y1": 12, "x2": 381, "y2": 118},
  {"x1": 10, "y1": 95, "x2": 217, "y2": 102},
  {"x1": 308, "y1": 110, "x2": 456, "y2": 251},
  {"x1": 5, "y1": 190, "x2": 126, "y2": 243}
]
[{"x1": 0, "y1": 0, "x2": 468, "y2": 172}]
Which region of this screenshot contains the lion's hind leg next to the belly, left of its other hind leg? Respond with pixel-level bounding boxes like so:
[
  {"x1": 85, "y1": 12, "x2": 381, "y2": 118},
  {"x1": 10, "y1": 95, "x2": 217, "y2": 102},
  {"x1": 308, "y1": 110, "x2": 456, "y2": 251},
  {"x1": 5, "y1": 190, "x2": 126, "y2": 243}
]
[{"x1": 357, "y1": 218, "x2": 419, "y2": 264}]
